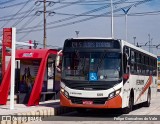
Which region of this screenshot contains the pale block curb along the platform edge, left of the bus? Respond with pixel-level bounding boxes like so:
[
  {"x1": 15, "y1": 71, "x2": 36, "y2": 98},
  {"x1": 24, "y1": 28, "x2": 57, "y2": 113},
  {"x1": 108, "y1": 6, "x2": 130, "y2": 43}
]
[{"x1": 0, "y1": 106, "x2": 73, "y2": 124}]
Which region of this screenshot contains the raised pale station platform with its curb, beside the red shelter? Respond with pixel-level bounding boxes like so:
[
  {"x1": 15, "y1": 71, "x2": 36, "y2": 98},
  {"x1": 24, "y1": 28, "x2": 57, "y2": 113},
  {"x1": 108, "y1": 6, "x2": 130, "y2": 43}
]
[{"x1": 0, "y1": 100, "x2": 73, "y2": 124}]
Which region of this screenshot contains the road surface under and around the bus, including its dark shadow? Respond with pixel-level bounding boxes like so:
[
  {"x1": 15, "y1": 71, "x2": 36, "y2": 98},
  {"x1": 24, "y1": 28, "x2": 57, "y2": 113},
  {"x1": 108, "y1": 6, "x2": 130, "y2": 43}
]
[{"x1": 30, "y1": 92, "x2": 160, "y2": 124}]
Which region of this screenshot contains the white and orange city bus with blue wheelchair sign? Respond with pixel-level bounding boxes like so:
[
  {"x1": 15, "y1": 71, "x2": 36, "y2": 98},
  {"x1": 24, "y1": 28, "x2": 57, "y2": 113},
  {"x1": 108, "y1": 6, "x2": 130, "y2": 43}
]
[{"x1": 60, "y1": 38, "x2": 157, "y2": 113}]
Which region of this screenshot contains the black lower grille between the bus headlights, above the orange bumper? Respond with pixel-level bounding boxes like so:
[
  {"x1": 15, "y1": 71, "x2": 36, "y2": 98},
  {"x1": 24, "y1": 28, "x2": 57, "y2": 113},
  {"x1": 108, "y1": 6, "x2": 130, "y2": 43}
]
[{"x1": 70, "y1": 97, "x2": 108, "y2": 104}]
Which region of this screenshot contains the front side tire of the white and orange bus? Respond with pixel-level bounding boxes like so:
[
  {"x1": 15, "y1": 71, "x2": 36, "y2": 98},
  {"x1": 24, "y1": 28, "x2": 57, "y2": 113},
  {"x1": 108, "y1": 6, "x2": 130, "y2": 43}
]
[{"x1": 122, "y1": 94, "x2": 134, "y2": 114}]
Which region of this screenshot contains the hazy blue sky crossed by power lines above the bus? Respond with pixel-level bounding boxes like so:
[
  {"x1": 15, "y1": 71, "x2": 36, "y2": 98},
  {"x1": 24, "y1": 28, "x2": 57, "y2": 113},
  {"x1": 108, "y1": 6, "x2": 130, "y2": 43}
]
[{"x1": 0, "y1": 0, "x2": 160, "y2": 55}]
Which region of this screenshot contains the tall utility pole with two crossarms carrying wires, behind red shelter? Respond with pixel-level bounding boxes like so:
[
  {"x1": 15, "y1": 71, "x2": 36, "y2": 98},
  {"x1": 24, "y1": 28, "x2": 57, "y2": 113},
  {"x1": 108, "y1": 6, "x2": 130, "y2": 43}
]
[{"x1": 35, "y1": 0, "x2": 55, "y2": 48}]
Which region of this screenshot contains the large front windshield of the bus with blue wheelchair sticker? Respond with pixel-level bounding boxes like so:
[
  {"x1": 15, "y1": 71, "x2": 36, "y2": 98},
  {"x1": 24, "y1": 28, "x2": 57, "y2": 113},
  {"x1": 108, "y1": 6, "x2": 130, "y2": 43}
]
[{"x1": 62, "y1": 51, "x2": 122, "y2": 81}]
